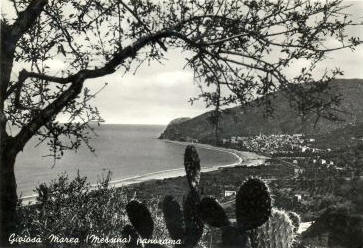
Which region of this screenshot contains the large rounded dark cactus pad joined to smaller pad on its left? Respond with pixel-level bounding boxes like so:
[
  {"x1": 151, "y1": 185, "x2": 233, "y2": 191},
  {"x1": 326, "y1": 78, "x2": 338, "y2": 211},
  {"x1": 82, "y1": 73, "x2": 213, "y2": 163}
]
[{"x1": 199, "y1": 175, "x2": 271, "y2": 248}]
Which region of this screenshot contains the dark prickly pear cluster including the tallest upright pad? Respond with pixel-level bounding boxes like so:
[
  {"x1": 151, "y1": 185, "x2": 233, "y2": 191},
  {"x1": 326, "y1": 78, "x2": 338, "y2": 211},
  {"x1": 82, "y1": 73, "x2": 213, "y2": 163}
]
[{"x1": 163, "y1": 145, "x2": 271, "y2": 248}]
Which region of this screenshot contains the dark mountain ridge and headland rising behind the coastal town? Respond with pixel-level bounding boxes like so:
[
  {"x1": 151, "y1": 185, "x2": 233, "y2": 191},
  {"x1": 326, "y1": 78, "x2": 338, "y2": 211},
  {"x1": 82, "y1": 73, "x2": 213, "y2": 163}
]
[{"x1": 160, "y1": 79, "x2": 363, "y2": 143}]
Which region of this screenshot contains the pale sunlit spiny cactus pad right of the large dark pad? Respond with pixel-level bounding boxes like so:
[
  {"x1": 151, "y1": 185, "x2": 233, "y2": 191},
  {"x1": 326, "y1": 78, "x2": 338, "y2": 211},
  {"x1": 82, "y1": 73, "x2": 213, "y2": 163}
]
[{"x1": 250, "y1": 209, "x2": 295, "y2": 248}]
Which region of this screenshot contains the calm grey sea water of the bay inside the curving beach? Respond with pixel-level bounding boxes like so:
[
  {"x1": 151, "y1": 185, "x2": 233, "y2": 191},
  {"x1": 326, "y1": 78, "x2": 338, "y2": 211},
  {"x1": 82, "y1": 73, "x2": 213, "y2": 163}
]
[{"x1": 15, "y1": 125, "x2": 236, "y2": 196}]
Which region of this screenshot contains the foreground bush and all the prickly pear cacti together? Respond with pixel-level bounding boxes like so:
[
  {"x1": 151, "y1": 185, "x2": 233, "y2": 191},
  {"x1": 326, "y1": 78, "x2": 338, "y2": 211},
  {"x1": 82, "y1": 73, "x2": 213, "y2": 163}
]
[{"x1": 13, "y1": 146, "x2": 299, "y2": 248}]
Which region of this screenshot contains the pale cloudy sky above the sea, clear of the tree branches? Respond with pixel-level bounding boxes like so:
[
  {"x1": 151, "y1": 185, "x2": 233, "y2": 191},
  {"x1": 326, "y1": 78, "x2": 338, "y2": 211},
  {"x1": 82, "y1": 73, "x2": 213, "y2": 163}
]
[{"x1": 2, "y1": 0, "x2": 363, "y2": 125}]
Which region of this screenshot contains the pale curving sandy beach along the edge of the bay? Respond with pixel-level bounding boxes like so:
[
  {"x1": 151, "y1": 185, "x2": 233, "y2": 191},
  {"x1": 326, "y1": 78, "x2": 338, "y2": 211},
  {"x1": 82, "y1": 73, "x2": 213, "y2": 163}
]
[{"x1": 22, "y1": 140, "x2": 267, "y2": 205}]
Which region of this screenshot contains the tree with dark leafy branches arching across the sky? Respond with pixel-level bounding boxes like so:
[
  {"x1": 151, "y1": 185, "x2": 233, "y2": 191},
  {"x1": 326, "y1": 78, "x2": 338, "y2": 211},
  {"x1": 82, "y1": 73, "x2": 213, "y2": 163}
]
[{"x1": 0, "y1": 0, "x2": 359, "y2": 244}]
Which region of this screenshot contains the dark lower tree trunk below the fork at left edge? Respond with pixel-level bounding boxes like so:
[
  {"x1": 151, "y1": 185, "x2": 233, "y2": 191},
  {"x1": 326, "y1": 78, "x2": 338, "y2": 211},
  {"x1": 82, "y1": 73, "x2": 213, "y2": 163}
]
[{"x1": 0, "y1": 137, "x2": 18, "y2": 247}]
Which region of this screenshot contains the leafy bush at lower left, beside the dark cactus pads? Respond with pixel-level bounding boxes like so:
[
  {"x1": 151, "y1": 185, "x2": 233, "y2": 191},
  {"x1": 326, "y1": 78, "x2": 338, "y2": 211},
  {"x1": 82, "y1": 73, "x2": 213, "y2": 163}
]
[{"x1": 17, "y1": 173, "x2": 171, "y2": 247}]
